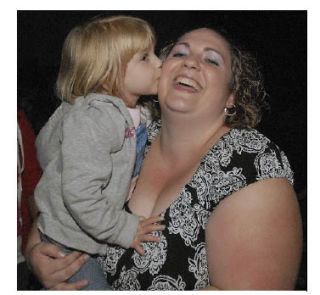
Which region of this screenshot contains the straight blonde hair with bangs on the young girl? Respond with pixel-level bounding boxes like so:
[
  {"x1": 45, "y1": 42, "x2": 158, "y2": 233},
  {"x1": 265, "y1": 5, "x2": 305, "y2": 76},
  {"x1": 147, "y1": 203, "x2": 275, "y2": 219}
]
[{"x1": 57, "y1": 15, "x2": 155, "y2": 103}]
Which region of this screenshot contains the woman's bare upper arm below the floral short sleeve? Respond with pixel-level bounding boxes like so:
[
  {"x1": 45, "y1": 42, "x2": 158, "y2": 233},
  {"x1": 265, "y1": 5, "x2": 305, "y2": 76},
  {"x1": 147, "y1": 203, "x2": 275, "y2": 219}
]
[{"x1": 206, "y1": 178, "x2": 302, "y2": 290}]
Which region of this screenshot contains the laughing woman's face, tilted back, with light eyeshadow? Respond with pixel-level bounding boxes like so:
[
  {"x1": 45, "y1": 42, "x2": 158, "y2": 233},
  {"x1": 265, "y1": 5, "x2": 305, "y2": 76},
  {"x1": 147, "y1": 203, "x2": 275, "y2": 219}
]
[{"x1": 158, "y1": 28, "x2": 233, "y2": 121}]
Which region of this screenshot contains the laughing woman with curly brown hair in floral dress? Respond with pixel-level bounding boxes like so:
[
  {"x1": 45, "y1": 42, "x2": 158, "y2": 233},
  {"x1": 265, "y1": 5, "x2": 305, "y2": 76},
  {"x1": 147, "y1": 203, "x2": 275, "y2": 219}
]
[{"x1": 25, "y1": 28, "x2": 301, "y2": 290}]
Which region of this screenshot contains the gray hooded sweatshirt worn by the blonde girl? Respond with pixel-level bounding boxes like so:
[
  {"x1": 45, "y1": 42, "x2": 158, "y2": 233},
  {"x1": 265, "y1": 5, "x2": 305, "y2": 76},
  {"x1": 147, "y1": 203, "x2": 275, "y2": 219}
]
[{"x1": 35, "y1": 94, "x2": 139, "y2": 255}]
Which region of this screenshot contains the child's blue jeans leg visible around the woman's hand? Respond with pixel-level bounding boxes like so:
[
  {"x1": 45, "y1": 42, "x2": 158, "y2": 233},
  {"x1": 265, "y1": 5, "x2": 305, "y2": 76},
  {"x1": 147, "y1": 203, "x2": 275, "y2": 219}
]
[{"x1": 40, "y1": 233, "x2": 112, "y2": 290}]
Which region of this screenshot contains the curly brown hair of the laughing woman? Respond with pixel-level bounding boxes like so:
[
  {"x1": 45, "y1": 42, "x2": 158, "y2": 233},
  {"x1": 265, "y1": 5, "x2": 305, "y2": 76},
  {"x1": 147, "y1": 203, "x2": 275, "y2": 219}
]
[{"x1": 160, "y1": 27, "x2": 268, "y2": 128}]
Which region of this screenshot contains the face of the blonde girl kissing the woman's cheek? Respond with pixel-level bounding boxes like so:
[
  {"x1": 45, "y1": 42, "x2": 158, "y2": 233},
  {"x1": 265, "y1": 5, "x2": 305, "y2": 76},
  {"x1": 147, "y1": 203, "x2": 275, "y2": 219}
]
[{"x1": 120, "y1": 46, "x2": 162, "y2": 107}]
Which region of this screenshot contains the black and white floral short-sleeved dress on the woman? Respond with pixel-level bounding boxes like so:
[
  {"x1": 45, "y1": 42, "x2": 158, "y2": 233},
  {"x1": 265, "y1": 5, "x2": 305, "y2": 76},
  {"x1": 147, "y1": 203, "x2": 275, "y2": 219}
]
[{"x1": 98, "y1": 122, "x2": 293, "y2": 290}]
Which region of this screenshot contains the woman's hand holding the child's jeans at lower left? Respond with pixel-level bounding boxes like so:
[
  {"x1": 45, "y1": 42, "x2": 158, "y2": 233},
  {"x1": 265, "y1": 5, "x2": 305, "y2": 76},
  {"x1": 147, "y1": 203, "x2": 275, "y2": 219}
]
[{"x1": 26, "y1": 242, "x2": 89, "y2": 290}]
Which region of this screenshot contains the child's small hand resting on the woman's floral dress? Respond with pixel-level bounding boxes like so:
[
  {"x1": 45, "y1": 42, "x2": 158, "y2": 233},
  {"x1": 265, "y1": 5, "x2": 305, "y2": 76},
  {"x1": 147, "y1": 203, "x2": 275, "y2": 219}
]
[{"x1": 131, "y1": 216, "x2": 165, "y2": 255}]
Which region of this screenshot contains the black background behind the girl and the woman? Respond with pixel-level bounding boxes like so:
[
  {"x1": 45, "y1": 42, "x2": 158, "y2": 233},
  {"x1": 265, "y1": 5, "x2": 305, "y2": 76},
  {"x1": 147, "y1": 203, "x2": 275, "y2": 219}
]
[{"x1": 17, "y1": 10, "x2": 307, "y2": 289}]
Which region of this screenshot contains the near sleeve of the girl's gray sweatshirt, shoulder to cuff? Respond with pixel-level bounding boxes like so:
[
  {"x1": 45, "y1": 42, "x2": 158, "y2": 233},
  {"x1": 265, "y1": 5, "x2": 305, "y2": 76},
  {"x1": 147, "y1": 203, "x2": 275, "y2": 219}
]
[{"x1": 62, "y1": 108, "x2": 139, "y2": 248}]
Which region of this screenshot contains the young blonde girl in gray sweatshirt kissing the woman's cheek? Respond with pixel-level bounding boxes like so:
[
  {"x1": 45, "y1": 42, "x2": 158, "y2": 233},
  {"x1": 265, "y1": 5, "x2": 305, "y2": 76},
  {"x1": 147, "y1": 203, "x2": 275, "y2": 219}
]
[{"x1": 35, "y1": 16, "x2": 163, "y2": 290}]
